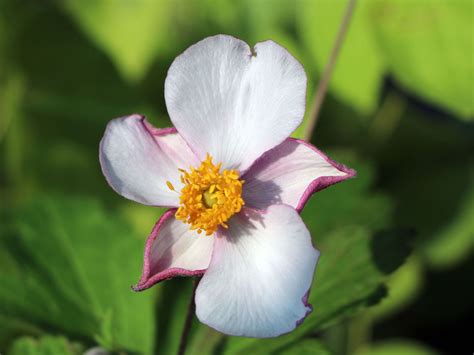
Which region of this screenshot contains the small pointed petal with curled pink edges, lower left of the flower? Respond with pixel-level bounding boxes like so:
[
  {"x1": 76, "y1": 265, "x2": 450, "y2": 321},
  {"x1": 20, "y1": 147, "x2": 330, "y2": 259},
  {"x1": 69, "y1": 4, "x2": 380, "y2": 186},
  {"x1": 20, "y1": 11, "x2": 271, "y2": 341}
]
[{"x1": 133, "y1": 209, "x2": 214, "y2": 291}]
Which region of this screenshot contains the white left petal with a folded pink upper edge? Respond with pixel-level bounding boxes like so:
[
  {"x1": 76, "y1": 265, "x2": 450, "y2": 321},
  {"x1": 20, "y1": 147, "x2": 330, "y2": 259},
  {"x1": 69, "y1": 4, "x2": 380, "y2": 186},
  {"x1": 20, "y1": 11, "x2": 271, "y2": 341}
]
[{"x1": 99, "y1": 115, "x2": 198, "y2": 207}]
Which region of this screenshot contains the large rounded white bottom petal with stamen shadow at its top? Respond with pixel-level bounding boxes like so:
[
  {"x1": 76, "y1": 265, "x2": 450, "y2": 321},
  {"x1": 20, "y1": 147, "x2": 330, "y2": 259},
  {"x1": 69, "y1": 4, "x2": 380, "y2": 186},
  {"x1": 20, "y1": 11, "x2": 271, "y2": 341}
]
[{"x1": 196, "y1": 205, "x2": 319, "y2": 338}]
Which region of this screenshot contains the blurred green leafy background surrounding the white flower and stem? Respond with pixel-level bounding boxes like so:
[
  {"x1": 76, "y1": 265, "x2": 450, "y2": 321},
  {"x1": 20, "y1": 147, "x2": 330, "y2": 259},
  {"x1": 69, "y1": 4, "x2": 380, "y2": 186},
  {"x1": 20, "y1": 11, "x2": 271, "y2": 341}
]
[{"x1": 0, "y1": 0, "x2": 474, "y2": 355}]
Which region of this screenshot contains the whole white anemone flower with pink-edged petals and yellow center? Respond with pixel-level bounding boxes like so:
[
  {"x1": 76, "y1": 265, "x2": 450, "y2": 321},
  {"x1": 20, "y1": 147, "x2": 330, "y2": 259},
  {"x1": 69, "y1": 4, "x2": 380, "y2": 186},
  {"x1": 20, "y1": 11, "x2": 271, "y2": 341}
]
[{"x1": 100, "y1": 35, "x2": 355, "y2": 337}]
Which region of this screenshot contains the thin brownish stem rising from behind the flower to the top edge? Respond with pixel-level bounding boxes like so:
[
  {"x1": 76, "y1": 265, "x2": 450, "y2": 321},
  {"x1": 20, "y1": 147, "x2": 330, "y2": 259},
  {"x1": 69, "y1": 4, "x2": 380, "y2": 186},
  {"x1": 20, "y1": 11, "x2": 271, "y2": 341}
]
[{"x1": 303, "y1": 0, "x2": 356, "y2": 141}]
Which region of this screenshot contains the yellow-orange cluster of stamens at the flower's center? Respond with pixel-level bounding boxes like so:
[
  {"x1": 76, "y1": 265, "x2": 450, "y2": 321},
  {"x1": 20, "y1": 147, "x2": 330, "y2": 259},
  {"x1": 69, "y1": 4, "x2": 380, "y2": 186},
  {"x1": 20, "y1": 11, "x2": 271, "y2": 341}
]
[{"x1": 167, "y1": 154, "x2": 245, "y2": 235}]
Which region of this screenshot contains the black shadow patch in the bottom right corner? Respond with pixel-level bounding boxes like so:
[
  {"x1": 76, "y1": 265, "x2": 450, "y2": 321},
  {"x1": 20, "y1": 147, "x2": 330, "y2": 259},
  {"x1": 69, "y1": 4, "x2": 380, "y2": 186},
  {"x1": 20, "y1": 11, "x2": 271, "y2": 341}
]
[{"x1": 374, "y1": 257, "x2": 474, "y2": 355}]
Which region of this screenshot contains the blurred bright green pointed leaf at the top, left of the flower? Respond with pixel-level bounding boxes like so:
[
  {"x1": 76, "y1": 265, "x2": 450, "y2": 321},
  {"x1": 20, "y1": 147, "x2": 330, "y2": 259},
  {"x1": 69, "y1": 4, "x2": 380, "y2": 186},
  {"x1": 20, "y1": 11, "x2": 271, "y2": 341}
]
[{"x1": 62, "y1": 0, "x2": 174, "y2": 82}]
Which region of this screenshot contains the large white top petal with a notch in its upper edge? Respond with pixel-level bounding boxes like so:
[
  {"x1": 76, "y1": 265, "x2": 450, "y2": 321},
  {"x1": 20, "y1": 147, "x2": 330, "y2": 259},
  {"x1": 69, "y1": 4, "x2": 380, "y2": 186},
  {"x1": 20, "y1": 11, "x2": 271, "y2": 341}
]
[{"x1": 165, "y1": 35, "x2": 306, "y2": 171}]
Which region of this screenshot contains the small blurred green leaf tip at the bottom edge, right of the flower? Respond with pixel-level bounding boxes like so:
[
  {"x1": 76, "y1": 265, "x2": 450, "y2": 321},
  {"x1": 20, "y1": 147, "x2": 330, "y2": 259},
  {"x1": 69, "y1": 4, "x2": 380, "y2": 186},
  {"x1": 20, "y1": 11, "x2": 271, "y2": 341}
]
[{"x1": 356, "y1": 339, "x2": 438, "y2": 355}]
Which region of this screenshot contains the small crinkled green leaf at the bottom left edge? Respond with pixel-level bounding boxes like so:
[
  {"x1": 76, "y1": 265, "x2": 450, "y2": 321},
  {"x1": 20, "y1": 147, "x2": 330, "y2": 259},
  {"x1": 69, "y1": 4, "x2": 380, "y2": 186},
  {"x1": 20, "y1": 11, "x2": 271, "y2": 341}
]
[{"x1": 7, "y1": 335, "x2": 84, "y2": 355}]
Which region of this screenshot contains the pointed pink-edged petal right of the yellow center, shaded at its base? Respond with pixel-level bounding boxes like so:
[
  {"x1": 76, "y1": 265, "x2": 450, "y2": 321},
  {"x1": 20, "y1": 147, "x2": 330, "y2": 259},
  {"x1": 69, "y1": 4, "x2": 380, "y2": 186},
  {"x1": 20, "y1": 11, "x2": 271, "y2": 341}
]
[{"x1": 242, "y1": 138, "x2": 356, "y2": 211}]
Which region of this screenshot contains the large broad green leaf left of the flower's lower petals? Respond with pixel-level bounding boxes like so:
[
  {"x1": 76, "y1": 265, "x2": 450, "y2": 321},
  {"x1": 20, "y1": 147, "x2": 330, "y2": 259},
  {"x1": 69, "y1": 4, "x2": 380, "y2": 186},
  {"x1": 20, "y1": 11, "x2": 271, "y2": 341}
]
[{"x1": 0, "y1": 198, "x2": 154, "y2": 354}]
